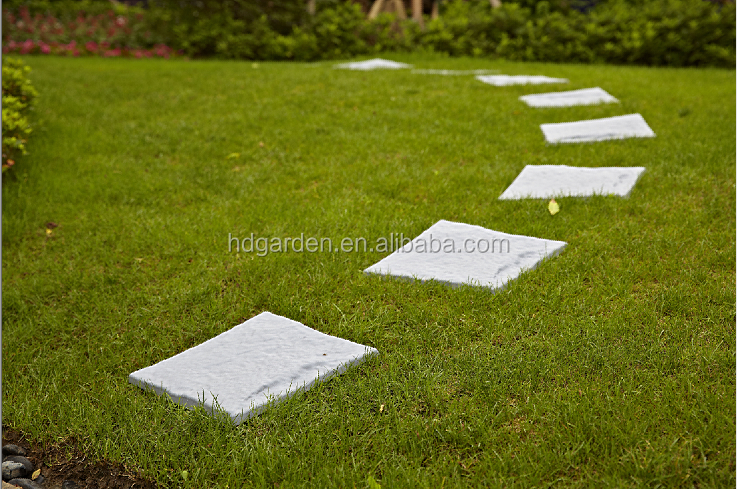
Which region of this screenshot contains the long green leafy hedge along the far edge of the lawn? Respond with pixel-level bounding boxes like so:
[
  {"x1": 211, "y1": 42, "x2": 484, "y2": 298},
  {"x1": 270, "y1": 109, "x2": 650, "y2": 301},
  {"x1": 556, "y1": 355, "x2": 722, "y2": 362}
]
[{"x1": 3, "y1": 0, "x2": 736, "y2": 68}]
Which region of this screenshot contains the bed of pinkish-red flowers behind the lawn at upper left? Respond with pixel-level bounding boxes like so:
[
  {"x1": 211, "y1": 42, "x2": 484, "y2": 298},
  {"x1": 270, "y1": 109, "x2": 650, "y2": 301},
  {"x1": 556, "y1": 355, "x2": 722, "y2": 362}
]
[{"x1": 2, "y1": 6, "x2": 179, "y2": 58}]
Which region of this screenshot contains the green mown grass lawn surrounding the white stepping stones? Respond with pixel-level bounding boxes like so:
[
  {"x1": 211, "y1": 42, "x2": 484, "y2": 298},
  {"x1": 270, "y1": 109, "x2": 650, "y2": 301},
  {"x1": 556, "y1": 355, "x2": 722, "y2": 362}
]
[{"x1": 2, "y1": 55, "x2": 736, "y2": 488}]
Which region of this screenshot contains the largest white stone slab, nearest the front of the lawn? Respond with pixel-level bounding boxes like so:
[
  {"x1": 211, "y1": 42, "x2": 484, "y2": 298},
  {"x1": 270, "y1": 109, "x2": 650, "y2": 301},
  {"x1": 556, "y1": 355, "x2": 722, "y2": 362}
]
[{"x1": 128, "y1": 312, "x2": 378, "y2": 424}]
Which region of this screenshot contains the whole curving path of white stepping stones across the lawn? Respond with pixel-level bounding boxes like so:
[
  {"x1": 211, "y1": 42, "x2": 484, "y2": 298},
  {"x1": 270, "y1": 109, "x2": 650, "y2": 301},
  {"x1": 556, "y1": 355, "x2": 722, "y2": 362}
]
[{"x1": 122, "y1": 65, "x2": 655, "y2": 424}]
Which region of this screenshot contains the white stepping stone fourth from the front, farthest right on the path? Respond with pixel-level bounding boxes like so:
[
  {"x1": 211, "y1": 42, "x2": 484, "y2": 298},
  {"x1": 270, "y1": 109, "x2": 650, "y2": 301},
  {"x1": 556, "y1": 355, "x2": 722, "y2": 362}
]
[{"x1": 541, "y1": 114, "x2": 656, "y2": 143}]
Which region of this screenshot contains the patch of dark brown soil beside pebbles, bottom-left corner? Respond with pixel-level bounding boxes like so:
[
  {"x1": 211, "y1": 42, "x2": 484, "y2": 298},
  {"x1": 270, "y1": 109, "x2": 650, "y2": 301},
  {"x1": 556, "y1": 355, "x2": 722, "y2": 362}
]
[{"x1": 3, "y1": 426, "x2": 159, "y2": 489}]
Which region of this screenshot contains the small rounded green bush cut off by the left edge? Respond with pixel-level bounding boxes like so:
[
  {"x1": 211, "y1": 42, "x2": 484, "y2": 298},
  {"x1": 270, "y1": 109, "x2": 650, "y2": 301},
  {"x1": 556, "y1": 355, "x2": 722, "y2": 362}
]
[{"x1": 2, "y1": 57, "x2": 38, "y2": 172}]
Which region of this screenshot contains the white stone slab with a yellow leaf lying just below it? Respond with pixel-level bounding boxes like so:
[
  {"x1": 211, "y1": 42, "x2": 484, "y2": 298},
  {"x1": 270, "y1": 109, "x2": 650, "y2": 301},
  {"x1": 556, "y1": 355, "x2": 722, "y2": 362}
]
[{"x1": 499, "y1": 165, "x2": 646, "y2": 200}]
